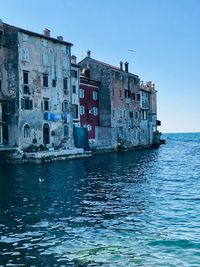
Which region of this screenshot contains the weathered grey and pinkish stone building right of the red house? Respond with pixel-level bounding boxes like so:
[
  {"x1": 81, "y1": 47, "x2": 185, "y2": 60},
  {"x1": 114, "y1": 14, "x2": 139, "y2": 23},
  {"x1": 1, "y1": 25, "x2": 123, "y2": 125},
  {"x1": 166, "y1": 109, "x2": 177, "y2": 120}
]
[{"x1": 79, "y1": 51, "x2": 157, "y2": 148}]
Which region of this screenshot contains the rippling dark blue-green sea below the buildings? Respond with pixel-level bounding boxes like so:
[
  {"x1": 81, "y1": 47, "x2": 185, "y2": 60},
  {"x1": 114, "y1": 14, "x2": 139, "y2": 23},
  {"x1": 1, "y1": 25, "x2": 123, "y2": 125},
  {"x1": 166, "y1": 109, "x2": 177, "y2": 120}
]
[{"x1": 0, "y1": 133, "x2": 200, "y2": 267}]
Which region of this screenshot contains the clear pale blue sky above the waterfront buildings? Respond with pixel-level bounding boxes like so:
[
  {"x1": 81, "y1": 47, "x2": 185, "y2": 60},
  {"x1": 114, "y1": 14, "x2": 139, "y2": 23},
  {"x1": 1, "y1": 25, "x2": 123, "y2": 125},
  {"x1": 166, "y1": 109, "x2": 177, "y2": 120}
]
[{"x1": 0, "y1": 0, "x2": 200, "y2": 133}]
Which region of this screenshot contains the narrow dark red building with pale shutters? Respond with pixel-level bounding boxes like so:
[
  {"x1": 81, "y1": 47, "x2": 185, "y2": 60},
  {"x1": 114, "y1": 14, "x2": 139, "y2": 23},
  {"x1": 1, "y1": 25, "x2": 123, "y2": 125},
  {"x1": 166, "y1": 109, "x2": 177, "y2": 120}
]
[{"x1": 80, "y1": 68, "x2": 99, "y2": 140}]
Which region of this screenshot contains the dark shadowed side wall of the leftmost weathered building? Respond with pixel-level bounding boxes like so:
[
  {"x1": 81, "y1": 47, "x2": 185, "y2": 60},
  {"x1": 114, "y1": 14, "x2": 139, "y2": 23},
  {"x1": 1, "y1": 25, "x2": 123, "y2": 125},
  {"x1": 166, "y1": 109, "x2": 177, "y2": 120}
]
[{"x1": 0, "y1": 24, "x2": 19, "y2": 146}]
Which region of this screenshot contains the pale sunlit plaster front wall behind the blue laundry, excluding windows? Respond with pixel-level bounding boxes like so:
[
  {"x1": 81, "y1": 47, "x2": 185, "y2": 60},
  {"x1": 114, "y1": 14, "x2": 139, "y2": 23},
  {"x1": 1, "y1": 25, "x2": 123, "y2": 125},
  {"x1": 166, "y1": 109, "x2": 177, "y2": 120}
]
[{"x1": 18, "y1": 32, "x2": 73, "y2": 150}]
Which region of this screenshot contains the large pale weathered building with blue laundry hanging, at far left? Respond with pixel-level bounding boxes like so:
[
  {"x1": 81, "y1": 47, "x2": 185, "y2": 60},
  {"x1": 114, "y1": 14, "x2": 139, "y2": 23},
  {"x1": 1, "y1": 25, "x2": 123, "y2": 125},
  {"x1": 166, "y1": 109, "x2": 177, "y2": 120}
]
[{"x1": 0, "y1": 22, "x2": 74, "y2": 152}]
